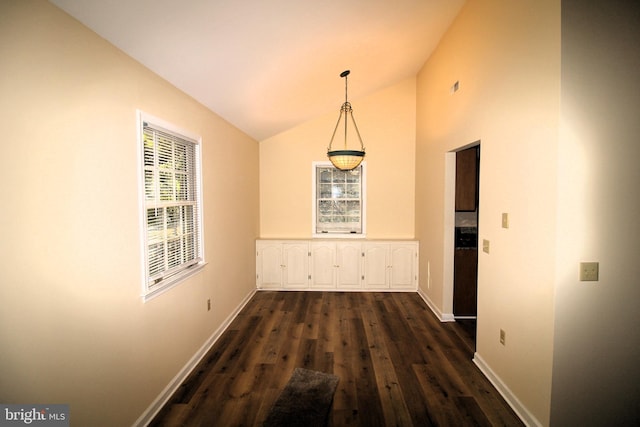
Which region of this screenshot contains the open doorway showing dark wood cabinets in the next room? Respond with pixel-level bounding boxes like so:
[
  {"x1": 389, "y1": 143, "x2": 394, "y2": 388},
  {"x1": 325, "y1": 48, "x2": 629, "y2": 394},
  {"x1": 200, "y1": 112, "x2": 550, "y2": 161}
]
[{"x1": 453, "y1": 143, "x2": 480, "y2": 324}]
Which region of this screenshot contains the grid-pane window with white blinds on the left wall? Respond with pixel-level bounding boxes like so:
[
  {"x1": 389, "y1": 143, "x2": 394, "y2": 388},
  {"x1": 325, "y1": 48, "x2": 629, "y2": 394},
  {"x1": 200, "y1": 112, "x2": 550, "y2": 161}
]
[{"x1": 141, "y1": 115, "x2": 203, "y2": 300}]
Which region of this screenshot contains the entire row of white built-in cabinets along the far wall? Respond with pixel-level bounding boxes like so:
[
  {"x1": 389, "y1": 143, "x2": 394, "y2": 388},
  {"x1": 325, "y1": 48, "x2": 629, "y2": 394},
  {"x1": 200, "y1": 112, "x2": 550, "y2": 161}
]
[{"x1": 256, "y1": 239, "x2": 418, "y2": 291}]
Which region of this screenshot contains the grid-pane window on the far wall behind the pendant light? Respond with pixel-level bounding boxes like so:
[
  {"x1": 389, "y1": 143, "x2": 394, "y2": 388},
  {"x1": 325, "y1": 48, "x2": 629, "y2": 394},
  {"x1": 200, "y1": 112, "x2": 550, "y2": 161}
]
[{"x1": 314, "y1": 164, "x2": 364, "y2": 235}]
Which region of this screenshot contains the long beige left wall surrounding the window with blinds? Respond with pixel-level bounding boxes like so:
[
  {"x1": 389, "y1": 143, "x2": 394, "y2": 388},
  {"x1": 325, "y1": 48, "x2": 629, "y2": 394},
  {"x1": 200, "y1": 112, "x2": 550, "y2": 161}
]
[{"x1": 0, "y1": 0, "x2": 259, "y2": 426}]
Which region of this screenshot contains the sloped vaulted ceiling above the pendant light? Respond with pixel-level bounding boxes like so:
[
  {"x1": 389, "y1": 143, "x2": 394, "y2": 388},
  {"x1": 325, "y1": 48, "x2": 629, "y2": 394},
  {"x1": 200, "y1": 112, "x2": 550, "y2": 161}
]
[{"x1": 50, "y1": 0, "x2": 465, "y2": 140}]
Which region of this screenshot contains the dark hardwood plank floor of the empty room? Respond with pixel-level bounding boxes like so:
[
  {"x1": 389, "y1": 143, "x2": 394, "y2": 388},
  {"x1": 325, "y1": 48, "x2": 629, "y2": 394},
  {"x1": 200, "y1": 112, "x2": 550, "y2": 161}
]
[{"x1": 150, "y1": 291, "x2": 523, "y2": 427}]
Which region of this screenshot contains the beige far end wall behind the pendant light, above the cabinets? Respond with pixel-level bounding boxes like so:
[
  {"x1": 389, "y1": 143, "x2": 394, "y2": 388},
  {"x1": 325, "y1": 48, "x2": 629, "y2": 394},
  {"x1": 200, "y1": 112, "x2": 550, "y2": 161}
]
[{"x1": 260, "y1": 73, "x2": 416, "y2": 239}]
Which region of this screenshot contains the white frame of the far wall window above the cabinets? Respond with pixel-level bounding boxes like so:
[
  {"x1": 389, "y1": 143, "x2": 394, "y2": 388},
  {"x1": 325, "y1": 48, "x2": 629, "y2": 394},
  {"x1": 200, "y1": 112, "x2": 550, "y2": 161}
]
[{"x1": 311, "y1": 161, "x2": 367, "y2": 239}]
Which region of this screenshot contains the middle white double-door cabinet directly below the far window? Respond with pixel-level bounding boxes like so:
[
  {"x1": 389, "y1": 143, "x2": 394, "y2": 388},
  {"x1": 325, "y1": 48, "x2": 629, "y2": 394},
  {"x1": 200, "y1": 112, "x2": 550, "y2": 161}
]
[{"x1": 310, "y1": 241, "x2": 362, "y2": 290}]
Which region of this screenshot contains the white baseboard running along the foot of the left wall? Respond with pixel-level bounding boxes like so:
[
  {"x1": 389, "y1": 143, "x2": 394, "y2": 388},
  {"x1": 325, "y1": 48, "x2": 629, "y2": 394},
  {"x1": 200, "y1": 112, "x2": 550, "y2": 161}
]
[{"x1": 133, "y1": 289, "x2": 256, "y2": 427}]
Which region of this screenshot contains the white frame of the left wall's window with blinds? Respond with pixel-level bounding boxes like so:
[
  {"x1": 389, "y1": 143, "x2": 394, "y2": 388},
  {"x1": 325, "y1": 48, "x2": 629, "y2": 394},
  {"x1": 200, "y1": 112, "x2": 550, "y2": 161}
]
[{"x1": 137, "y1": 110, "x2": 206, "y2": 302}]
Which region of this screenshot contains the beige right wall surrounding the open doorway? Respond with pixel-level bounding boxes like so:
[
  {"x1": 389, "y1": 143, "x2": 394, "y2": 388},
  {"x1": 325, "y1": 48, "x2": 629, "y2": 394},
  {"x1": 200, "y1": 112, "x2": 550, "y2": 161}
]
[{"x1": 416, "y1": 0, "x2": 560, "y2": 424}]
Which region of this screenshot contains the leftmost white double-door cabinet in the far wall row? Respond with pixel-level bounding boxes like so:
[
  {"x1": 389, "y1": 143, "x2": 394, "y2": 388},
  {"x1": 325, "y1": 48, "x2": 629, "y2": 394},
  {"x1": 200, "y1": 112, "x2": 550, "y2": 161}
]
[{"x1": 256, "y1": 240, "x2": 309, "y2": 289}]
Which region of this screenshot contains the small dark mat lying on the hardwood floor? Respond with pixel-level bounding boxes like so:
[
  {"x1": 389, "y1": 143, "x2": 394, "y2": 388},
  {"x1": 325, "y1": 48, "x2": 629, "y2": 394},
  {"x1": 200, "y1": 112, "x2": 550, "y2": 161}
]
[{"x1": 263, "y1": 368, "x2": 339, "y2": 427}]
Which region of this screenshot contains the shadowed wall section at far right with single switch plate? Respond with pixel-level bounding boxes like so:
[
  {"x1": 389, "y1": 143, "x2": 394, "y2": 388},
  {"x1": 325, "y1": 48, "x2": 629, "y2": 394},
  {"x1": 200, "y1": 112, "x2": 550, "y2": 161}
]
[{"x1": 551, "y1": 0, "x2": 640, "y2": 426}]
